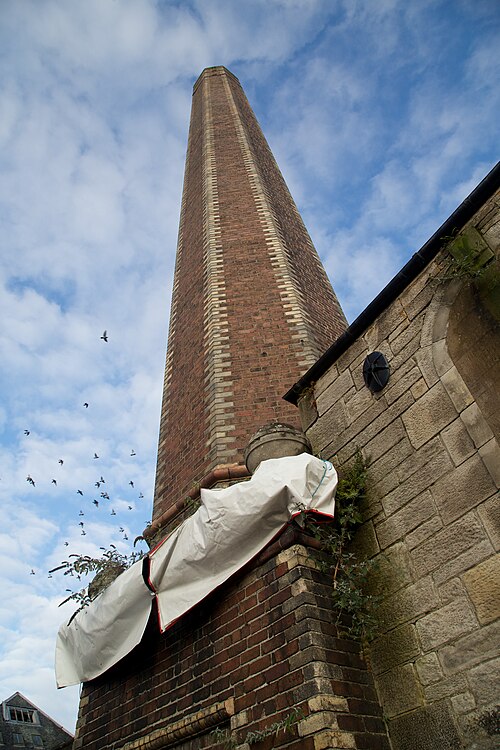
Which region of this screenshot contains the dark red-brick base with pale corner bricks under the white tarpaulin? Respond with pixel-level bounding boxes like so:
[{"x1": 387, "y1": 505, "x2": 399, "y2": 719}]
[{"x1": 74, "y1": 540, "x2": 389, "y2": 750}]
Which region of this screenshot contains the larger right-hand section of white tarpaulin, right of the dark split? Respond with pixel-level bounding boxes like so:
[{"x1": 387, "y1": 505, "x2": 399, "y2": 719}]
[{"x1": 150, "y1": 453, "x2": 337, "y2": 631}]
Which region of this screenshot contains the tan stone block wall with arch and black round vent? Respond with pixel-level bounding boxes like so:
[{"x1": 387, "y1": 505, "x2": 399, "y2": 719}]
[{"x1": 299, "y1": 189, "x2": 500, "y2": 750}]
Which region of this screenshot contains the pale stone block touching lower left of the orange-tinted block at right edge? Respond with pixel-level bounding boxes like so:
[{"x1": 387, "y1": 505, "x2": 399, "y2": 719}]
[{"x1": 417, "y1": 598, "x2": 477, "y2": 651}]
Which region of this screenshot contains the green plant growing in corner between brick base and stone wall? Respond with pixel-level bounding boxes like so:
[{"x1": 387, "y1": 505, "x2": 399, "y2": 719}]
[{"x1": 305, "y1": 450, "x2": 380, "y2": 641}]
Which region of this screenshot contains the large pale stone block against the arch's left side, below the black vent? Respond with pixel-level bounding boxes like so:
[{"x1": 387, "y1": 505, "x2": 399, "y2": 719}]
[{"x1": 403, "y1": 382, "x2": 457, "y2": 448}]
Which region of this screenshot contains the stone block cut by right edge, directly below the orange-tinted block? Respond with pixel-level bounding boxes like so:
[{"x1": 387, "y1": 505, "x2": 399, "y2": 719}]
[{"x1": 439, "y1": 621, "x2": 500, "y2": 674}]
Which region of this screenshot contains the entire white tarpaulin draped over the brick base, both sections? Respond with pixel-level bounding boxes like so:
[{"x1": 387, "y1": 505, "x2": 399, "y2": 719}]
[{"x1": 56, "y1": 453, "x2": 337, "y2": 687}]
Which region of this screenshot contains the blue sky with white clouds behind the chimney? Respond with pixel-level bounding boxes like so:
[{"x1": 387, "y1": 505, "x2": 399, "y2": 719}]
[{"x1": 0, "y1": 0, "x2": 500, "y2": 731}]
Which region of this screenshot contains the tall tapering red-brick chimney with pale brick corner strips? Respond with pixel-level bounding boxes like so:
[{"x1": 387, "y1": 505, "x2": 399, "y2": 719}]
[{"x1": 154, "y1": 68, "x2": 346, "y2": 519}]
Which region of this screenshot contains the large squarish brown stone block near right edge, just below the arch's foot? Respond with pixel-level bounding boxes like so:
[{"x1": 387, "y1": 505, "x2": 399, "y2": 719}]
[{"x1": 431, "y1": 454, "x2": 496, "y2": 524}]
